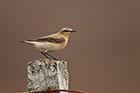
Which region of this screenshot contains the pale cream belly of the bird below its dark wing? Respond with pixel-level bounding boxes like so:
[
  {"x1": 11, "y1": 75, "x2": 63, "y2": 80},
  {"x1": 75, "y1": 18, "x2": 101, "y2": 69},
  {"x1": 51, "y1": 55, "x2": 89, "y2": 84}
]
[{"x1": 34, "y1": 42, "x2": 66, "y2": 52}]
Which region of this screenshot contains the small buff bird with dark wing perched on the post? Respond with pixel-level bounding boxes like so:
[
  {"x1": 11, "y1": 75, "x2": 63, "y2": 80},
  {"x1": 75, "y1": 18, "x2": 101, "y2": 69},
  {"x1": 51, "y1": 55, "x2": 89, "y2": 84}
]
[{"x1": 20, "y1": 27, "x2": 75, "y2": 60}]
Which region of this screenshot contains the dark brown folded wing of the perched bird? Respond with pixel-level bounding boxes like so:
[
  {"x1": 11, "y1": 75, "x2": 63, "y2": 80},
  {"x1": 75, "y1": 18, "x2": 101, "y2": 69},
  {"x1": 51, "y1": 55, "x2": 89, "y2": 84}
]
[{"x1": 35, "y1": 37, "x2": 65, "y2": 43}]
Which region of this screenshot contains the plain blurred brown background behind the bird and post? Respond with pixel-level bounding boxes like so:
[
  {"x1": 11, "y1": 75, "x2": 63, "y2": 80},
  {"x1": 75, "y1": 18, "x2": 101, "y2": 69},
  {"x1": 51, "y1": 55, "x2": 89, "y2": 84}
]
[{"x1": 0, "y1": 0, "x2": 140, "y2": 93}]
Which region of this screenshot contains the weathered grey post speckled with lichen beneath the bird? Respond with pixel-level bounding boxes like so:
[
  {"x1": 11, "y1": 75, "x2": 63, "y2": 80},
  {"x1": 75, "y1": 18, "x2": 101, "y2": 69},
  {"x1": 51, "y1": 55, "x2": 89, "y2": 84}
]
[{"x1": 27, "y1": 59, "x2": 68, "y2": 91}]
